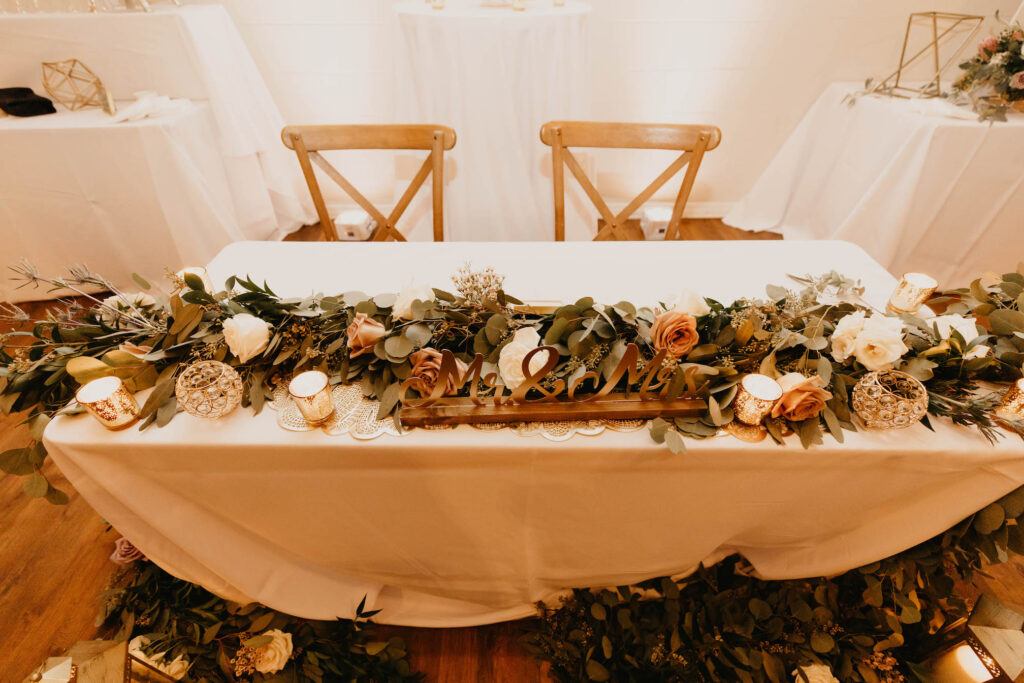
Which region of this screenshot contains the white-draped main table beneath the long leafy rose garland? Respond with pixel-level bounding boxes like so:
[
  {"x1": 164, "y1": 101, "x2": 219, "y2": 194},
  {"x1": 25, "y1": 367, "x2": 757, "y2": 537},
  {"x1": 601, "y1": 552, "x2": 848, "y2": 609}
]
[{"x1": 45, "y1": 242, "x2": 1024, "y2": 627}]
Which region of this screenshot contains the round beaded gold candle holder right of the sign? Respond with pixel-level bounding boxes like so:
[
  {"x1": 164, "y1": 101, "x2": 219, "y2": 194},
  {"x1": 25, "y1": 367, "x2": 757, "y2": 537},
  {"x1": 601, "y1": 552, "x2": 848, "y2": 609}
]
[{"x1": 850, "y1": 370, "x2": 928, "y2": 429}]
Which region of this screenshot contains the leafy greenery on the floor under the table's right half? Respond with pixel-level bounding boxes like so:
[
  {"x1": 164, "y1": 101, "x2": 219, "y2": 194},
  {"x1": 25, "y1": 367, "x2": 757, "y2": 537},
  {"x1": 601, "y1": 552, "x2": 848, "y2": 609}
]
[{"x1": 524, "y1": 487, "x2": 1024, "y2": 683}]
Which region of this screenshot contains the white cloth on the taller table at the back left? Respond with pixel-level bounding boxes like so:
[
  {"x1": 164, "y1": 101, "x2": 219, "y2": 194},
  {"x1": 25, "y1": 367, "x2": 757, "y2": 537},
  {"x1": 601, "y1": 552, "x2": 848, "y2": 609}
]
[{"x1": 0, "y1": 5, "x2": 314, "y2": 240}]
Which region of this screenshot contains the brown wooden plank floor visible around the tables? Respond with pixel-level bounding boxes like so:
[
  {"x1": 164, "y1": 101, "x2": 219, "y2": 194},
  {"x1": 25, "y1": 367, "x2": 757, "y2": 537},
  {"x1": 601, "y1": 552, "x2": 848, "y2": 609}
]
[{"x1": 8, "y1": 219, "x2": 1024, "y2": 683}]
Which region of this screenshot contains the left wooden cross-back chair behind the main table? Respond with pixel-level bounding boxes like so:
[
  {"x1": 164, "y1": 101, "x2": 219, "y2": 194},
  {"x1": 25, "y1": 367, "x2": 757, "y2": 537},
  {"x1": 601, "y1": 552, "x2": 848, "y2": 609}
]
[{"x1": 281, "y1": 124, "x2": 456, "y2": 242}]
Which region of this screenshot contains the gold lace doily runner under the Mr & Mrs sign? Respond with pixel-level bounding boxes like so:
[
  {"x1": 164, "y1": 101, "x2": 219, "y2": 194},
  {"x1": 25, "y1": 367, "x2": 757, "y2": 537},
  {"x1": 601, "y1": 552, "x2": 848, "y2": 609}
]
[{"x1": 270, "y1": 384, "x2": 647, "y2": 441}]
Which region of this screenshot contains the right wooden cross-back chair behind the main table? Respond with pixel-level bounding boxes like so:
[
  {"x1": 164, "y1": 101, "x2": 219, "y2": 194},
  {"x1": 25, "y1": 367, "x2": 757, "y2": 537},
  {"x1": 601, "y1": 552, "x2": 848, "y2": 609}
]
[{"x1": 541, "y1": 121, "x2": 722, "y2": 242}]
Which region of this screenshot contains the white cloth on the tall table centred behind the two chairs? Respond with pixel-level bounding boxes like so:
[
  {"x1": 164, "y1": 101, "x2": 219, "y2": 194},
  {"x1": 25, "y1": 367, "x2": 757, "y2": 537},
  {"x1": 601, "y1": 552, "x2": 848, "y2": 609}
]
[{"x1": 395, "y1": 0, "x2": 596, "y2": 241}]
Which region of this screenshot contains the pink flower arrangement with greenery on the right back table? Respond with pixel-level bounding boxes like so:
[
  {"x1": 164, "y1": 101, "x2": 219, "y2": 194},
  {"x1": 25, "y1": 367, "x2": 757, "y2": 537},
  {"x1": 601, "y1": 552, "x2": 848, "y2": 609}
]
[{"x1": 953, "y1": 17, "x2": 1024, "y2": 121}]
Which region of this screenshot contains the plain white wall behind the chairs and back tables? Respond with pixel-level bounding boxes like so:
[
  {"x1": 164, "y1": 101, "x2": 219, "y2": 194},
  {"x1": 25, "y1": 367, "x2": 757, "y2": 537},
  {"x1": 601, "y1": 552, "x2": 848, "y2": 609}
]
[{"x1": 199, "y1": 0, "x2": 1018, "y2": 216}]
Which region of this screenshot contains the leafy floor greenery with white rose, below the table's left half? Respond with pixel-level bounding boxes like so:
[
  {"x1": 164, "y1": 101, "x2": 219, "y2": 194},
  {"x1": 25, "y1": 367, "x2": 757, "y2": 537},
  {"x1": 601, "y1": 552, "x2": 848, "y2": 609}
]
[{"x1": 100, "y1": 562, "x2": 422, "y2": 683}]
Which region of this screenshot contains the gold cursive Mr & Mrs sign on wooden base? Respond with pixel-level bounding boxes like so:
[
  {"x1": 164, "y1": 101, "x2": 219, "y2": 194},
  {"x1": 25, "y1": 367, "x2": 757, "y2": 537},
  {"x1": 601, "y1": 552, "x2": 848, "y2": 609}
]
[{"x1": 398, "y1": 344, "x2": 708, "y2": 427}]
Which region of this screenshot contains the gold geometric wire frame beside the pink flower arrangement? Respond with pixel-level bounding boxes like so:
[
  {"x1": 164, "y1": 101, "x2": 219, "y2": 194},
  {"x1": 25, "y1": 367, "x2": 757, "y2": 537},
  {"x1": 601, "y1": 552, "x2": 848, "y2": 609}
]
[{"x1": 871, "y1": 12, "x2": 985, "y2": 97}]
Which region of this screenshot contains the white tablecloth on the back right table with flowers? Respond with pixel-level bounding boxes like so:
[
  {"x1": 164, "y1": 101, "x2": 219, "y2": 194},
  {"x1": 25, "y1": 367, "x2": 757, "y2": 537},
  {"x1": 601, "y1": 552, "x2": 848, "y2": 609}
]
[{"x1": 725, "y1": 84, "x2": 1024, "y2": 287}]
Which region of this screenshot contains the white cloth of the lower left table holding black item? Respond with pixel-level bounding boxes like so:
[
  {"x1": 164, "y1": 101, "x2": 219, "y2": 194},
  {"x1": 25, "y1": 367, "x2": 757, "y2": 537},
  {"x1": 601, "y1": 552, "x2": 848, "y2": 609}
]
[{"x1": 0, "y1": 103, "x2": 243, "y2": 301}]
